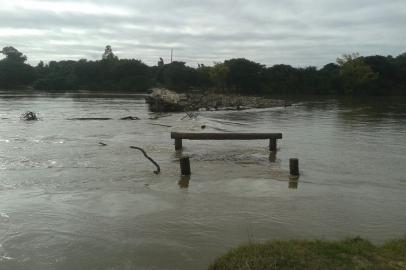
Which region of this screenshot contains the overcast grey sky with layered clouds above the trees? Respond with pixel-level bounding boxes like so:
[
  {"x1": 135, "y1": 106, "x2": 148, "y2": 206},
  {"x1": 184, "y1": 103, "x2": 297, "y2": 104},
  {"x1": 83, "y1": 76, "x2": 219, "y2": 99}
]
[{"x1": 0, "y1": 0, "x2": 406, "y2": 67}]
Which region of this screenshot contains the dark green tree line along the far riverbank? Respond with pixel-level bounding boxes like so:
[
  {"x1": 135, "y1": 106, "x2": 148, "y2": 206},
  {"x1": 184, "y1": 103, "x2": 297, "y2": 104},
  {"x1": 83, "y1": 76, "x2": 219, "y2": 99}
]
[{"x1": 0, "y1": 46, "x2": 406, "y2": 95}]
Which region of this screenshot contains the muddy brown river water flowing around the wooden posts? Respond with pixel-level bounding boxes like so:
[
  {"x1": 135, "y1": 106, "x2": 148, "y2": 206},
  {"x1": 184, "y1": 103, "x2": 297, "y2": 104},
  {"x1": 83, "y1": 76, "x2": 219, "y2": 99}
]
[{"x1": 0, "y1": 92, "x2": 406, "y2": 270}]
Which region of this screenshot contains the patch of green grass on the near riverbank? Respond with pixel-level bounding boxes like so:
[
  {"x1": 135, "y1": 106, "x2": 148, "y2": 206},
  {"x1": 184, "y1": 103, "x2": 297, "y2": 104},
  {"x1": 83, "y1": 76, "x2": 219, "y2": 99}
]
[{"x1": 209, "y1": 237, "x2": 406, "y2": 270}]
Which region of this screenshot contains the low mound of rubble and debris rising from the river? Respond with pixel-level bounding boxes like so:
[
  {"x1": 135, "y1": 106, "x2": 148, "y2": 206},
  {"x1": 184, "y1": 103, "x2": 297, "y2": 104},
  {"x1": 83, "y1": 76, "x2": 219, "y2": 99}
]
[{"x1": 146, "y1": 88, "x2": 291, "y2": 112}]
